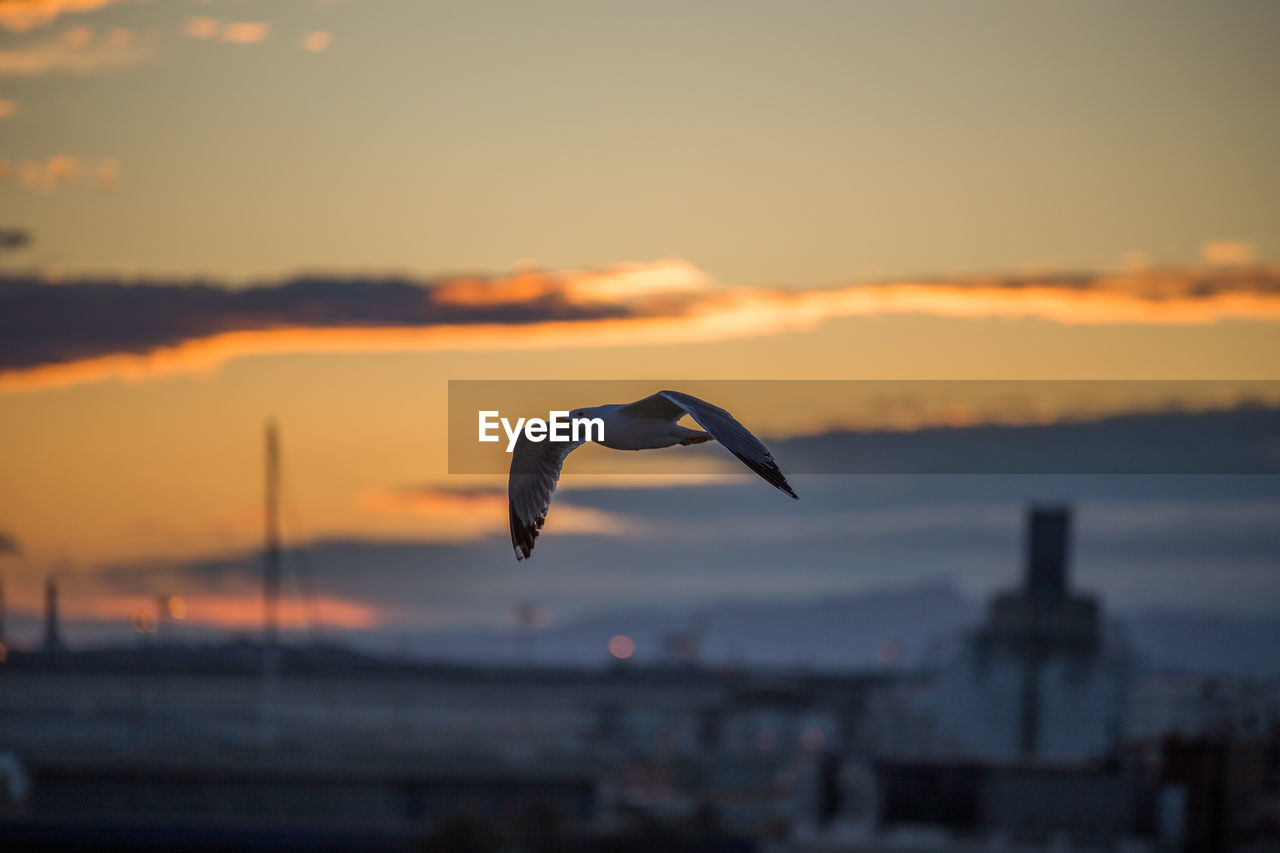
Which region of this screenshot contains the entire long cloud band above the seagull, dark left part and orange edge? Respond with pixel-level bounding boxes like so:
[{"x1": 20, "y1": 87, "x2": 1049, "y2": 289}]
[{"x1": 0, "y1": 258, "x2": 1280, "y2": 391}]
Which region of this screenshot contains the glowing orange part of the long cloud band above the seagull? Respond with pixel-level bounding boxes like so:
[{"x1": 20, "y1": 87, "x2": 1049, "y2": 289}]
[{"x1": 0, "y1": 261, "x2": 1280, "y2": 392}]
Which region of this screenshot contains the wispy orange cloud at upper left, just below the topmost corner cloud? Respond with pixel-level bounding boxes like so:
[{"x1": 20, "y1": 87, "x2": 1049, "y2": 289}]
[{"x1": 0, "y1": 27, "x2": 152, "y2": 77}]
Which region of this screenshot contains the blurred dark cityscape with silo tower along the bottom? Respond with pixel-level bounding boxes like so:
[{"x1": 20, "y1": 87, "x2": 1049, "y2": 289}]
[{"x1": 0, "y1": 506, "x2": 1280, "y2": 853}]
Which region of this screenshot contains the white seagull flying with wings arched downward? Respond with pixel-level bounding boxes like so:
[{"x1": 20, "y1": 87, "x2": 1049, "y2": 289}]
[{"x1": 507, "y1": 391, "x2": 800, "y2": 560}]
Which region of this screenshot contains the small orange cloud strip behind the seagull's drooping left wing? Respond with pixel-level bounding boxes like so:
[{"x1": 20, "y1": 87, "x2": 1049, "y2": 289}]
[{"x1": 360, "y1": 488, "x2": 636, "y2": 542}]
